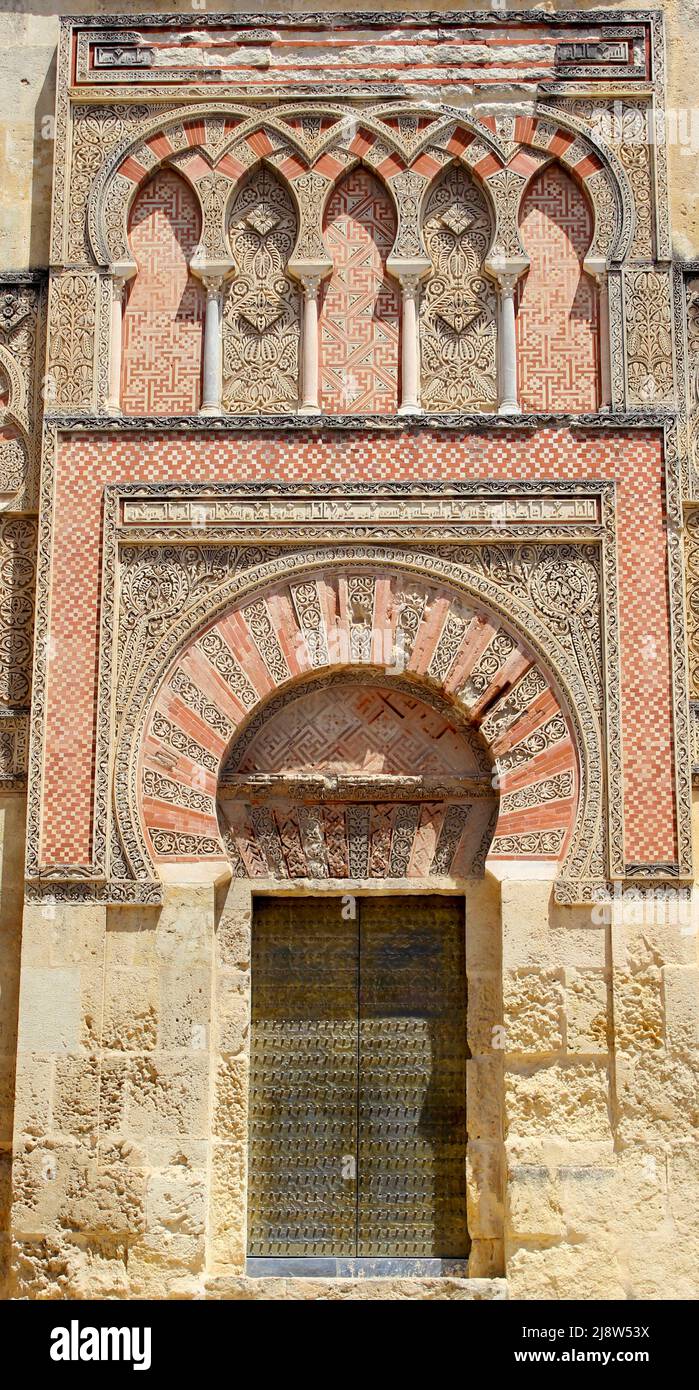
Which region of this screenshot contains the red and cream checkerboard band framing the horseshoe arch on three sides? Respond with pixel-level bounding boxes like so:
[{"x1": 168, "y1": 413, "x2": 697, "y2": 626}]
[{"x1": 42, "y1": 427, "x2": 675, "y2": 863}]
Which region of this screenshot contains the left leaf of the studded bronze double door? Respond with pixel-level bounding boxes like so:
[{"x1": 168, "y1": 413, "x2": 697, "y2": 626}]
[{"x1": 249, "y1": 898, "x2": 359, "y2": 1255}]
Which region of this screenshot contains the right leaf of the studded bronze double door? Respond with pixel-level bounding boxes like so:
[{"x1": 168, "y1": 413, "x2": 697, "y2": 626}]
[{"x1": 357, "y1": 895, "x2": 468, "y2": 1258}]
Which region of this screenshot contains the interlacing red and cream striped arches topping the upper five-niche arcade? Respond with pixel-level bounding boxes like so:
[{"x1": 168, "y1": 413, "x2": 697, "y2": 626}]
[{"x1": 88, "y1": 103, "x2": 634, "y2": 265}]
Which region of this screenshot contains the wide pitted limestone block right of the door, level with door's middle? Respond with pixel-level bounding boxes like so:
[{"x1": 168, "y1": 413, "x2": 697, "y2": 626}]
[{"x1": 504, "y1": 1062, "x2": 610, "y2": 1138}]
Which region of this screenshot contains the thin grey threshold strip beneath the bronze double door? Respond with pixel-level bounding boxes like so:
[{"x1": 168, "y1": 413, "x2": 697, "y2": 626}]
[{"x1": 245, "y1": 1255, "x2": 468, "y2": 1279}]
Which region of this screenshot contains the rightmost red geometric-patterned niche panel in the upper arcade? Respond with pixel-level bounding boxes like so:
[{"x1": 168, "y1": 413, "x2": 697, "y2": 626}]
[{"x1": 517, "y1": 164, "x2": 600, "y2": 411}]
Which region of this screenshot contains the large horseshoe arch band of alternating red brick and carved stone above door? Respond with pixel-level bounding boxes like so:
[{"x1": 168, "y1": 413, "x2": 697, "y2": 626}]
[{"x1": 117, "y1": 556, "x2": 600, "y2": 895}]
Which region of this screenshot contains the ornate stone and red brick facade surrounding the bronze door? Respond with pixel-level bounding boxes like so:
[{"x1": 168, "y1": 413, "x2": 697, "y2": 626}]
[{"x1": 0, "y1": 6, "x2": 699, "y2": 1300}]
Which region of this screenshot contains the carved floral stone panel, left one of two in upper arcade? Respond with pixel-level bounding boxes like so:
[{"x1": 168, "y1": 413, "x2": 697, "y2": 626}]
[{"x1": 222, "y1": 167, "x2": 300, "y2": 414}]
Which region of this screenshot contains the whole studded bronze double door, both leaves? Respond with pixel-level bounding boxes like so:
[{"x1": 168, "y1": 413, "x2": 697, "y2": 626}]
[{"x1": 249, "y1": 897, "x2": 468, "y2": 1258}]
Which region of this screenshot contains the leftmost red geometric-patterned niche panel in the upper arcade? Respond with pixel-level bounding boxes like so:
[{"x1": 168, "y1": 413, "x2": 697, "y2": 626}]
[{"x1": 121, "y1": 168, "x2": 206, "y2": 416}]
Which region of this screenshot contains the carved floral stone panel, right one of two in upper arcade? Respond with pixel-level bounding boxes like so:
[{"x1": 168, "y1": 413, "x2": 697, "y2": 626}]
[{"x1": 420, "y1": 168, "x2": 497, "y2": 410}]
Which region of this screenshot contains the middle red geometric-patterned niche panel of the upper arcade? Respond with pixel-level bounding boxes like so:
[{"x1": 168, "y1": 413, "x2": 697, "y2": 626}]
[{"x1": 320, "y1": 165, "x2": 400, "y2": 414}]
